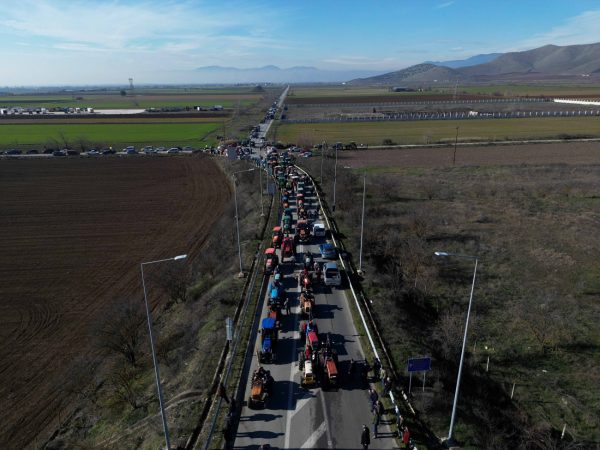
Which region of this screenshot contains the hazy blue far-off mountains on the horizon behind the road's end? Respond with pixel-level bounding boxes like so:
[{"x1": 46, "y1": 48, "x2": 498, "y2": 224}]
[{"x1": 195, "y1": 65, "x2": 381, "y2": 84}]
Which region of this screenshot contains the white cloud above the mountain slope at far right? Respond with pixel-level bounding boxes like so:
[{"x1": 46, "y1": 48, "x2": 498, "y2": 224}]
[{"x1": 513, "y1": 10, "x2": 600, "y2": 51}]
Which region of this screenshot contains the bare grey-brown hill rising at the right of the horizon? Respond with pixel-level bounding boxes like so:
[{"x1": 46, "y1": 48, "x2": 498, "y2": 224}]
[{"x1": 349, "y1": 43, "x2": 600, "y2": 85}]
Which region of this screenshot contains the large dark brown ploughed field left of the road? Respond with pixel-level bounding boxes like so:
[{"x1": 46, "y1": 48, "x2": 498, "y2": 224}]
[{"x1": 0, "y1": 156, "x2": 230, "y2": 449}]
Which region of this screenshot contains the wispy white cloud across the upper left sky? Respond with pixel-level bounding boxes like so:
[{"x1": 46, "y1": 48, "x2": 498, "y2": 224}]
[{"x1": 0, "y1": 0, "x2": 284, "y2": 52}]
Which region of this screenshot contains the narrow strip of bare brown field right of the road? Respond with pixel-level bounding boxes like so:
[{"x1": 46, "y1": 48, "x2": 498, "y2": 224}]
[{"x1": 339, "y1": 142, "x2": 600, "y2": 168}]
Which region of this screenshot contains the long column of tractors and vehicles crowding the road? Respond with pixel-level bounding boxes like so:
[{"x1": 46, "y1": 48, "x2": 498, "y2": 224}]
[{"x1": 248, "y1": 151, "x2": 342, "y2": 408}]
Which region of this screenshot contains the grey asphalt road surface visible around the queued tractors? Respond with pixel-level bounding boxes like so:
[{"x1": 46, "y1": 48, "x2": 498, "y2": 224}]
[{"x1": 234, "y1": 163, "x2": 396, "y2": 449}]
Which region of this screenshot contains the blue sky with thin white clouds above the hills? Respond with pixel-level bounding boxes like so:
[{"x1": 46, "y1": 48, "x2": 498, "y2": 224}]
[{"x1": 0, "y1": 0, "x2": 600, "y2": 86}]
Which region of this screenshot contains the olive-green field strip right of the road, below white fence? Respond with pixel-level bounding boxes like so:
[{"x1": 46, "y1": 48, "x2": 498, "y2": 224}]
[{"x1": 270, "y1": 117, "x2": 600, "y2": 145}]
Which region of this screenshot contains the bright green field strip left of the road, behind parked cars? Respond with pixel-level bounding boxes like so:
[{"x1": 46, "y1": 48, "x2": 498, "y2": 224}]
[{"x1": 0, "y1": 122, "x2": 222, "y2": 147}]
